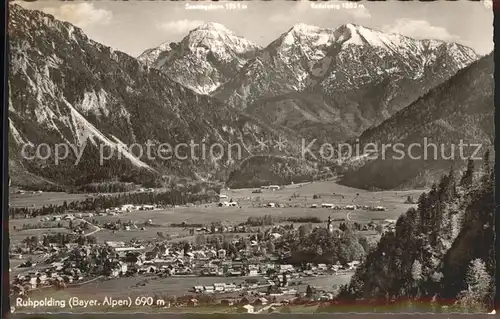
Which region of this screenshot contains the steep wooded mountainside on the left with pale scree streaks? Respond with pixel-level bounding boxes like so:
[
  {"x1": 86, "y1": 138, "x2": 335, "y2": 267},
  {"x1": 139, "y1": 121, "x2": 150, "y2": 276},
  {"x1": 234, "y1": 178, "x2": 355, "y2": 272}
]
[{"x1": 9, "y1": 5, "x2": 290, "y2": 190}]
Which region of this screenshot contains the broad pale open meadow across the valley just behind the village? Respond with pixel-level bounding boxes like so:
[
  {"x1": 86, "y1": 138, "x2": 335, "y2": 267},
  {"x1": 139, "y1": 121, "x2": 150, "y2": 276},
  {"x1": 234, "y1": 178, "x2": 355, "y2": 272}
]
[{"x1": 89, "y1": 182, "x2": 422, "y2": 226}]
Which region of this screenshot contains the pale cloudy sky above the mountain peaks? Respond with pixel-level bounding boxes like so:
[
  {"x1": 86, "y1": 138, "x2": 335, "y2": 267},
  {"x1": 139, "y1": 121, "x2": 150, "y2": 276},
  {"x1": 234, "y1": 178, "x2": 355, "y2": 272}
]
[{"x1": 15, "y1": 0, "x2": 493, "y2": 57}]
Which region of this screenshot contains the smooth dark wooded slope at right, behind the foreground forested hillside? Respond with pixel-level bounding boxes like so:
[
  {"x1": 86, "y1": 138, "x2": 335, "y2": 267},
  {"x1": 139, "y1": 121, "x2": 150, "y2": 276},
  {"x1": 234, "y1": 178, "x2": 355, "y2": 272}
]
[{"x1": 342, "y1": 54, "x2": 495, "y2": 189}]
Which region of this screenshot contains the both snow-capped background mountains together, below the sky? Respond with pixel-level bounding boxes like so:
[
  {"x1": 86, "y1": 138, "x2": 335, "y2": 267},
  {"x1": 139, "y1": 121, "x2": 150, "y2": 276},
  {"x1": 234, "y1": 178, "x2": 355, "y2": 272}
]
[{"x1": 139, "y1": 23, "x2": 477, "y2": 141}]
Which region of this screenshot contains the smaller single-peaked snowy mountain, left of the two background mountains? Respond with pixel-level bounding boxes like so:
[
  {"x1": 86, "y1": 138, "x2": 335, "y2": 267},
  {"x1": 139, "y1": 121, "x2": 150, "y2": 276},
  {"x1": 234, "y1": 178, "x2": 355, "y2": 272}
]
[{"x1": 138, "y1": 22, "x2": 260, "y2": 94}]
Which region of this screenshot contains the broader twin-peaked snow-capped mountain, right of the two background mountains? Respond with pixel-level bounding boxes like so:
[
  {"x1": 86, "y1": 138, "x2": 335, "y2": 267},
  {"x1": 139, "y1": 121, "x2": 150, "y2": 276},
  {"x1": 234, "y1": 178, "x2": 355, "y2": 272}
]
[{"x1": 213, "y1": 24, "x2": 477, "y2": 141}]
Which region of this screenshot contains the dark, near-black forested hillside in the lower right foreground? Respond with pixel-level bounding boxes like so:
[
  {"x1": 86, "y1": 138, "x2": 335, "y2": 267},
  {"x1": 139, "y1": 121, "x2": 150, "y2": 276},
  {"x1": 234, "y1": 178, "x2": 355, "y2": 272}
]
[{"x1": 330, "y1": 152, "x2": 495, "y2": 311}]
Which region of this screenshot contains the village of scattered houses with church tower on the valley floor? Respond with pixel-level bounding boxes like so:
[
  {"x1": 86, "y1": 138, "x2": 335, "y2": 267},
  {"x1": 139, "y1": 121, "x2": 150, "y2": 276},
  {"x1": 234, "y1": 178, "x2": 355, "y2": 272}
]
[{"x1": 10, "y1": 181, "x2": 414, "y2": 312}]
